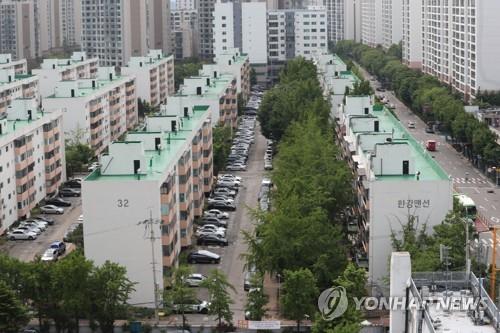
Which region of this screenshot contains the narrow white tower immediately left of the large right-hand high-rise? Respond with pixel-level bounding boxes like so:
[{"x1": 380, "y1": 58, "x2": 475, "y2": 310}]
[{"x1": 401, "y1": 0, "x2": 423, "y2": 69}]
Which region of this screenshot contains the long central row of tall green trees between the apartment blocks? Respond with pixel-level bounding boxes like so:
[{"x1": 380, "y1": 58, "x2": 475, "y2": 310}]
[{"x1": 245, "y1": 58, "x2": 365, "y2": 332}]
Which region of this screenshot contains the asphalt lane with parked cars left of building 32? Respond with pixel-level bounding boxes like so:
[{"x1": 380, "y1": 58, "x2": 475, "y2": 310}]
[{"x1": 1, "y1": 198, "x2": 82, "y2": 262}]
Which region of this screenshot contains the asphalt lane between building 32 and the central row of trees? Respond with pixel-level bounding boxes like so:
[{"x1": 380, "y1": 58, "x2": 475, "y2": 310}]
[{"x1": 168, "y1": 123, "x2": 266, "y2": 325}]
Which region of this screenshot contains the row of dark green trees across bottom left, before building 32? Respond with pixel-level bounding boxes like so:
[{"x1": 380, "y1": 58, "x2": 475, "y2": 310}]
[{"x1": 0, "y1": 251, "x2": 134, "y2": 333}]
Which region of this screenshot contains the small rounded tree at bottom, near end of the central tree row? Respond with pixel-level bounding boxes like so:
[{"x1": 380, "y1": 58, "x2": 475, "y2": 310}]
[{"x1": 280, "y1": 268, "x2": 319, "y2": 332}]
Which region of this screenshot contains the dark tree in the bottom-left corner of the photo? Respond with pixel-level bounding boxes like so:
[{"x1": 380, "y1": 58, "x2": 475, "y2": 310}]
[{"x1": 0, "y1": 280, "x2": 29, "y2": 333}]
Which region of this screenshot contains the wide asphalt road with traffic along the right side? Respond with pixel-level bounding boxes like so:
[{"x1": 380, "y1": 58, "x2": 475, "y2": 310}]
[{"x1": 360, "y1": 67, "x2": 500, "y2": 266}]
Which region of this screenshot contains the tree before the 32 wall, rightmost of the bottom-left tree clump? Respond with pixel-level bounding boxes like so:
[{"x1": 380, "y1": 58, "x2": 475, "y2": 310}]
[{"x1": 88, "y1": 261, "x2": 135, "y2": 333}]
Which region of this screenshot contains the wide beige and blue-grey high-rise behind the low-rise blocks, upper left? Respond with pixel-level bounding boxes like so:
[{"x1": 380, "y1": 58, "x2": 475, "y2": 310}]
[{"x1": 82, "y1": 0, "x2": 171, "y2": 66}]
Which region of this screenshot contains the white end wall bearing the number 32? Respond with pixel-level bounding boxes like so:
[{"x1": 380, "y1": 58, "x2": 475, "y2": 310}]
[{"x1": 82, "y1": 180, "x2": 163, "y2": 307}]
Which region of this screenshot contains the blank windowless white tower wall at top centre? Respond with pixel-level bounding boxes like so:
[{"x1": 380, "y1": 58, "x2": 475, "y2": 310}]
[{"x1": 242, "y1": 2, "x2": 267, "y2": 64}]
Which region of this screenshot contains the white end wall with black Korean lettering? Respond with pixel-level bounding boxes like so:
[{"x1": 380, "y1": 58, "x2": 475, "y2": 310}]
[{"x1": 368, "y1": 180, "x2": 453, "y2": 286}]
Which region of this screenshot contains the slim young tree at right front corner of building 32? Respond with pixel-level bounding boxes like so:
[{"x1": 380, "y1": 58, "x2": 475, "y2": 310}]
[{"x1": 164, "y1": 265, "x2": 196, "y2": 329}]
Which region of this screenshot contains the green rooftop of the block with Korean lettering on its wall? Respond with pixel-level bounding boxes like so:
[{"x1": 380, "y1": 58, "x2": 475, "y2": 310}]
[{"x1": 352, "y1": 107, "x2": 449, "y2": 181}]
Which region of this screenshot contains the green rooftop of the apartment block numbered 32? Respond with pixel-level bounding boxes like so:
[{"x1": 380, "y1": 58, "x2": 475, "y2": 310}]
[{"x1": 85, "y1": 105, "x2": 209, "y2": 181}]
